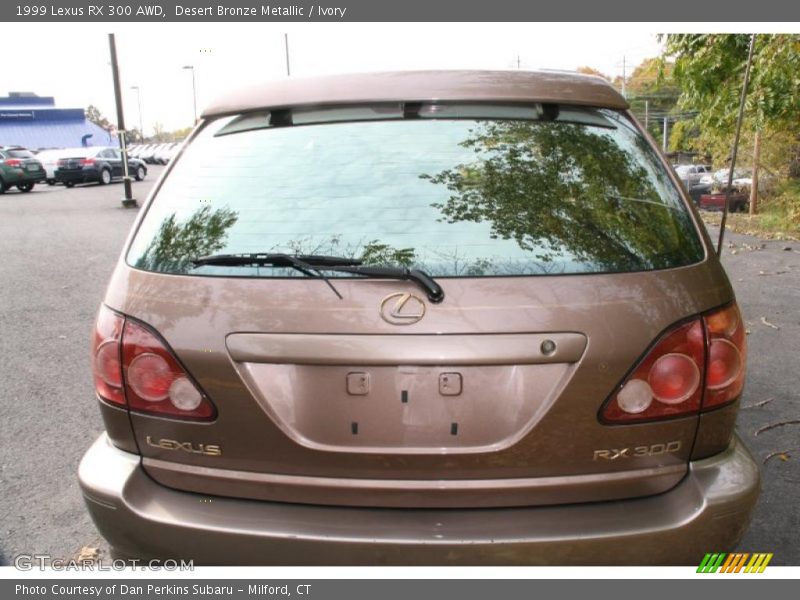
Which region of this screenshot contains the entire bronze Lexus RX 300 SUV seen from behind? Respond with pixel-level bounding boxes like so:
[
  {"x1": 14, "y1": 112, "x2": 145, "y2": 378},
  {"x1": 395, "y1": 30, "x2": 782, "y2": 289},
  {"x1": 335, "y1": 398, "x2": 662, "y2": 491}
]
[{"x1": 79, "y1": 71, "x2": 760, "y2": 564}]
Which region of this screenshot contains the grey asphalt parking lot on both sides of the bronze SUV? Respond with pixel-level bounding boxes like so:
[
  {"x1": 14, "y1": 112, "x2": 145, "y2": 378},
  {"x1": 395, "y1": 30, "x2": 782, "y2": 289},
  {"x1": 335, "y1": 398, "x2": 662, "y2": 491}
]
[{"x1": 0, "y1": 172, "x2": 800, "y2": 565}]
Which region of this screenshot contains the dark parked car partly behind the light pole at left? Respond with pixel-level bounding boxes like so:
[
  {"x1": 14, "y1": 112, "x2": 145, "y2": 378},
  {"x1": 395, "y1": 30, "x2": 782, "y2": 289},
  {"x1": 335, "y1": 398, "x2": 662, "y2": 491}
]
[{"x1": 55, "y1": 147, "x2": 147, "y2": 187}]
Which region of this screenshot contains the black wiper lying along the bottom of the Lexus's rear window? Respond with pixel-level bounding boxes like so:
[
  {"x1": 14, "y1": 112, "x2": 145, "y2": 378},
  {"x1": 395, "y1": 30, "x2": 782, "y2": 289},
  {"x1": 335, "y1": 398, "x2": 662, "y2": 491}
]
[{"x1": 191, "y1": 253, "x2": 444, "y2": 303}]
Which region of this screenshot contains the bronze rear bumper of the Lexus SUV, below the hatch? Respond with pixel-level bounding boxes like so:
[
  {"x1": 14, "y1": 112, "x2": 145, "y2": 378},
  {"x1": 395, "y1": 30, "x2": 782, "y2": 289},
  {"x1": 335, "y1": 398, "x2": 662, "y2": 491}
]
[{"x1": 79, "y1": 434, "x2": 760, "y2": 565}]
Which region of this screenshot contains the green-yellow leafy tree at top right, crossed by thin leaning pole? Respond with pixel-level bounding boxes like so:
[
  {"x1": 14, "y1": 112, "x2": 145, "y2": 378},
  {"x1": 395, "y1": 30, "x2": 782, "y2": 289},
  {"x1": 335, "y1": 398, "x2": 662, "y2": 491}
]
[{"x1": 666, "y1": 34, "x2": 800, "y2": 213}]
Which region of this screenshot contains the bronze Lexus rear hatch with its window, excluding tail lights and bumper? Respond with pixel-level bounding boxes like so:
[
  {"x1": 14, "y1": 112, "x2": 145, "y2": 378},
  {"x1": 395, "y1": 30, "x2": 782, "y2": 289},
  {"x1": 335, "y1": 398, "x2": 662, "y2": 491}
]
[{"x1": 106, "y1": 106, "x2": 731, "y2": 507}]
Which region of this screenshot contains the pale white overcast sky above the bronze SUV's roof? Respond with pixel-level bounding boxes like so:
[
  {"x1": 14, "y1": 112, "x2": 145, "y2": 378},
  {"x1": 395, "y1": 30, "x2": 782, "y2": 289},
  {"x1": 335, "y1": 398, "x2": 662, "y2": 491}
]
[{"x1": 0, "y1": 23, "x2": 780, "y2": 134}]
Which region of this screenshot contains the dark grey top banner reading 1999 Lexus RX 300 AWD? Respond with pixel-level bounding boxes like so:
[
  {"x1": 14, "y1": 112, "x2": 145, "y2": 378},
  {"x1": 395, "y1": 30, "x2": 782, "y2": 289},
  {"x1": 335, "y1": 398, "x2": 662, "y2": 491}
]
[{"x1": 0, "y1": 0, "x2": 800, "y2": 23}]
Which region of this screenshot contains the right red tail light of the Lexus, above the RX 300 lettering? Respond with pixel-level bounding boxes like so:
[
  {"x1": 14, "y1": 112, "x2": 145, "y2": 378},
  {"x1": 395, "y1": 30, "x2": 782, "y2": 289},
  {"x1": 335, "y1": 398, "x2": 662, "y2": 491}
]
[{"x1": 600, "y1": 304, "x2": 746, "y2": 423}]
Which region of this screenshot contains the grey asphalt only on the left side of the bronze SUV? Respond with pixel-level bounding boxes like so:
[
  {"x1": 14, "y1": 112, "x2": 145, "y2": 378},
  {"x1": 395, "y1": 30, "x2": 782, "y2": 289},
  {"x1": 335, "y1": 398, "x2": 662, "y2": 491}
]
[{"x1": 0, "y1": 167, "x2": 161, "y2": 564}]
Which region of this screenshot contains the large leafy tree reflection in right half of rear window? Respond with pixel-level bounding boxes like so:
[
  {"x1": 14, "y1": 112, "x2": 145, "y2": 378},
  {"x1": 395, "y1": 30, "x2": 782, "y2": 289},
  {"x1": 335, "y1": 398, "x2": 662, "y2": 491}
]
[{"x1": 422, "y1": 121, "x2": 697, "y2": 271}]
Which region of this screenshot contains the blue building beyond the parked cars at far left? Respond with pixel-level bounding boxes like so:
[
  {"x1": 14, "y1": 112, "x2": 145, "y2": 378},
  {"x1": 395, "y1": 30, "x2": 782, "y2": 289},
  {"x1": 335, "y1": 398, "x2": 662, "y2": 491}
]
[{"x1": 0, "y1": 92, "x2": 119, "y2": 150}]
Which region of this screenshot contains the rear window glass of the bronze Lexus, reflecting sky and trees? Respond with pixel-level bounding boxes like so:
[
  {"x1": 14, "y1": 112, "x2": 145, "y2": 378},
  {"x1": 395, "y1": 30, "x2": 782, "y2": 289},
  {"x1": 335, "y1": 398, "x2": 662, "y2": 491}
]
[{"x1": 127, "y1": 105, "x2": 704, "y2": 277}]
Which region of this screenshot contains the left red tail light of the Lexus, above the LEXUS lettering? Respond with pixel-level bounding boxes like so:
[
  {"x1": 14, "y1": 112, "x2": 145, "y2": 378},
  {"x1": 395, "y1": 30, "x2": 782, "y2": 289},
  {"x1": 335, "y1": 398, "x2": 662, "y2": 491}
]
[{"x1": 92, "y1": 307, "x2": 216, "y2": 420}]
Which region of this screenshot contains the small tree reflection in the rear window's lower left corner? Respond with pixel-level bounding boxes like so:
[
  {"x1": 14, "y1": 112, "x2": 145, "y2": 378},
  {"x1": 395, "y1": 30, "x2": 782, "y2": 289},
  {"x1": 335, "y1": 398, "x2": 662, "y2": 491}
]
[{"x1": 135, "y1": 205, "x2": 238, "y2": 273}]
